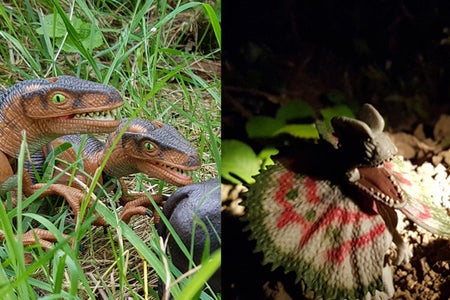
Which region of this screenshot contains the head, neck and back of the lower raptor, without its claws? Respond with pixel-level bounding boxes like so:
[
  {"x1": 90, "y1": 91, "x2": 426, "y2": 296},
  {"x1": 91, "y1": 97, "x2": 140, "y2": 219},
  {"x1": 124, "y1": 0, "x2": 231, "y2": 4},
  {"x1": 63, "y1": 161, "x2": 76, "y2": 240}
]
[{"x1": 25, "y1": 118, "x2": 200, "y2": 186}]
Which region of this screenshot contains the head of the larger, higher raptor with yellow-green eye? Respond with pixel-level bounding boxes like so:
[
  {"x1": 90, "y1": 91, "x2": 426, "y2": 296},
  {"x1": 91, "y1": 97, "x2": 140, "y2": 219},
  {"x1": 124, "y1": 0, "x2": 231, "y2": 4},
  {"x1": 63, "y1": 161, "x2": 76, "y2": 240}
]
[{"x1": 21, "y1": 76, "x2": 123, "y2": 134}]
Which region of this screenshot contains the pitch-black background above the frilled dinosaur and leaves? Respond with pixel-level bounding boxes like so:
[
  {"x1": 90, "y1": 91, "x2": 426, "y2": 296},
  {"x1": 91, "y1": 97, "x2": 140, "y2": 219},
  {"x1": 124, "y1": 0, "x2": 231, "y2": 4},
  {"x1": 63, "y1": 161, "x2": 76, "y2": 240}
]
[{"x1": 223, "y1": 0, "x2": 450, "y2": 138}]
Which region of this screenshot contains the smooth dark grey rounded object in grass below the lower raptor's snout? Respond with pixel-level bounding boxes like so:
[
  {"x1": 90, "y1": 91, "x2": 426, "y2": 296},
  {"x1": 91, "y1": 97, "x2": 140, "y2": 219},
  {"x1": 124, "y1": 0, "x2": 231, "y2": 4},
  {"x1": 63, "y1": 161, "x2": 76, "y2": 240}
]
[{"x1": 158, "y1": 179, "x2": 221, "y2": 293}]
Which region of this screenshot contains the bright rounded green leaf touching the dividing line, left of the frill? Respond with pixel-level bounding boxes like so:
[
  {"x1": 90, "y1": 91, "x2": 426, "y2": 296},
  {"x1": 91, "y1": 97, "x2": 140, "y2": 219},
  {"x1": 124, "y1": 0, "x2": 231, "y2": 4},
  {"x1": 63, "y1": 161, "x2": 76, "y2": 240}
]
[{"x1": 222, "y1": 140, "x2": 259, "y2": 184}]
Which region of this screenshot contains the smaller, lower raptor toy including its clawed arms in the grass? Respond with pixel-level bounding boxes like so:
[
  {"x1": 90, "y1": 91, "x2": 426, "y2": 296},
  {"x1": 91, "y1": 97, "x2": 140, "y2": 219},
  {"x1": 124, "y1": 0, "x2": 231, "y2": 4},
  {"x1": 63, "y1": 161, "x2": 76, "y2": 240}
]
[{"x1": 25, "y1": 119, "x2": 200, "y2": 226}]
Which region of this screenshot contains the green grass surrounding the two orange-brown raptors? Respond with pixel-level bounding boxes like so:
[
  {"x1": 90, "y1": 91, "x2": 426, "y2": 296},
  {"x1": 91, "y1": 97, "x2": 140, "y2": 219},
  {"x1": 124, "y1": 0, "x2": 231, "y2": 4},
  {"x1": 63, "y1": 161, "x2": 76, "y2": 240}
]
[{"x1": 0, "y1": 0, "x2": 221, "y2": 299}]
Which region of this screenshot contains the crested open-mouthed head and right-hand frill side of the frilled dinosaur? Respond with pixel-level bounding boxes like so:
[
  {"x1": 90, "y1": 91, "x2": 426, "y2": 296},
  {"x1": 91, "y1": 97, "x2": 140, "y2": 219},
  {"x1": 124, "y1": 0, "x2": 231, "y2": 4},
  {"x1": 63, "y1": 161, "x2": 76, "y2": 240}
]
[{"x1": 332, "y1": 106, "x2": 450, "y2": 239}]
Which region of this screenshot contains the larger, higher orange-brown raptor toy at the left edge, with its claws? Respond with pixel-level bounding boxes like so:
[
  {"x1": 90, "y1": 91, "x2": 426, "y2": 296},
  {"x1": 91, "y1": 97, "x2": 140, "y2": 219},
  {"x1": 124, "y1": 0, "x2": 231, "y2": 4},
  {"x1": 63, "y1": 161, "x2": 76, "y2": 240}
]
[{"x1": 0, "y1": 76, "x2": 123, "y2": 247}]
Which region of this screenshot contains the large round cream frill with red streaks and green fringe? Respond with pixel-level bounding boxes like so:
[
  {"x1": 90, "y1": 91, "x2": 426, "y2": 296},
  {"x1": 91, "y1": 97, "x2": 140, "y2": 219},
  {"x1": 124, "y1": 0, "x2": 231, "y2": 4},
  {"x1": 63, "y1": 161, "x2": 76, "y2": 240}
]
[{"x1": 244, "y1": 163, "x2": 392, "y2": 299}]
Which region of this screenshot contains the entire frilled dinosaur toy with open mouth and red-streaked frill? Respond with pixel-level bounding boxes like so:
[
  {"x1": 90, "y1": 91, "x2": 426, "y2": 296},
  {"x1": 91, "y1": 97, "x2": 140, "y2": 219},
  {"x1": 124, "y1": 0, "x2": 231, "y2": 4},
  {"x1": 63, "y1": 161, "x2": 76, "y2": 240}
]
[{"x1": 244, "y1": 104, "x2": 450, "y2": 299}]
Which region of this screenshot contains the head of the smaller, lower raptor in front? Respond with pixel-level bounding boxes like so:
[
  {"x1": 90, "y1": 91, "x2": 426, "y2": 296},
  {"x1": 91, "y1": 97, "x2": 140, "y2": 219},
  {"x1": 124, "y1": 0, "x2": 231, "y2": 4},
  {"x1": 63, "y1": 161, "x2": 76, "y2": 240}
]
[{"x1": 105, "y1": 119, "x2": 200, "y2": 186}]
